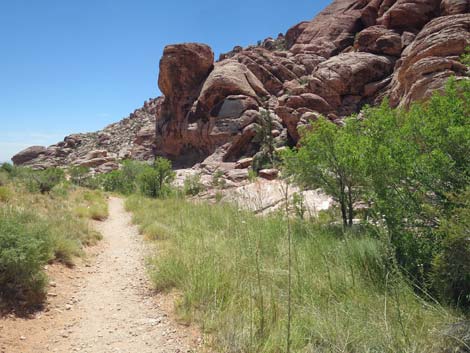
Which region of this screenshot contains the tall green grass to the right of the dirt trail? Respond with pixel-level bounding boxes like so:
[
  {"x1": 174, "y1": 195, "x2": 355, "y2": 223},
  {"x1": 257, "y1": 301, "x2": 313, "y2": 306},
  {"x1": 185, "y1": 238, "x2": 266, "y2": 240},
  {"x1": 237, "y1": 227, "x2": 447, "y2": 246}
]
[{"x1": 126, "y1": 196, "x2": 457, "y2": 353}]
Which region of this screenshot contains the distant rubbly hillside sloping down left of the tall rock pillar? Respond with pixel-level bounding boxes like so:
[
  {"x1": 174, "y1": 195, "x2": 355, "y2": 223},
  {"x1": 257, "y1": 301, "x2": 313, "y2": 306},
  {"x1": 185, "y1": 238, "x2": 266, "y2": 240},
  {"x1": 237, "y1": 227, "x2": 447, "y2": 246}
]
[{"x1": 12, "y1": 98, "x2": 162, "y2": 172}]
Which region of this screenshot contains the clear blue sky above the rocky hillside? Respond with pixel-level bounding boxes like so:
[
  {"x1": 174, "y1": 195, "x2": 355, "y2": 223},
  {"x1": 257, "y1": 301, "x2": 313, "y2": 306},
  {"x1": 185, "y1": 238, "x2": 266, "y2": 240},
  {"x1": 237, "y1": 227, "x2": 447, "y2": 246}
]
[{"x1": 0, "y1": 0, "x2": 329, "y2": 161}]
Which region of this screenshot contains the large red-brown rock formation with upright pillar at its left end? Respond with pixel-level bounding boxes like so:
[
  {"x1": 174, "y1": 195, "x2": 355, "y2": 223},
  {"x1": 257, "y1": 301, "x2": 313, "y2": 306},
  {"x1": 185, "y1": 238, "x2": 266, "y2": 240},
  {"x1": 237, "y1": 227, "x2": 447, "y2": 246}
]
[{"x1": 156, "y1": 0, "x2": 470, "y2": 165}]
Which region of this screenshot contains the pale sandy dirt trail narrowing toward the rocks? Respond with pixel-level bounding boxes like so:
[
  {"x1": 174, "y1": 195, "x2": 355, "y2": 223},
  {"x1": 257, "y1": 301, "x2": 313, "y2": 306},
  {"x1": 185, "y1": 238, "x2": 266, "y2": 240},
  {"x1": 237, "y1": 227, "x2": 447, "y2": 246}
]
[{"x1": 0, "y1": 198, "x2": 199, "y2": 353}]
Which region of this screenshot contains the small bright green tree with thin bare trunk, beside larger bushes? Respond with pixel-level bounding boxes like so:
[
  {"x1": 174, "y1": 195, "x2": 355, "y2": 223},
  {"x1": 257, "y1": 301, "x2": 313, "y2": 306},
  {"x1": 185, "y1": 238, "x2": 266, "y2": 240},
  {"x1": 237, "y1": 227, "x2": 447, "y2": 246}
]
[{"x1": 284, "y1": 118, "x2": 364, "y2": 226}]
